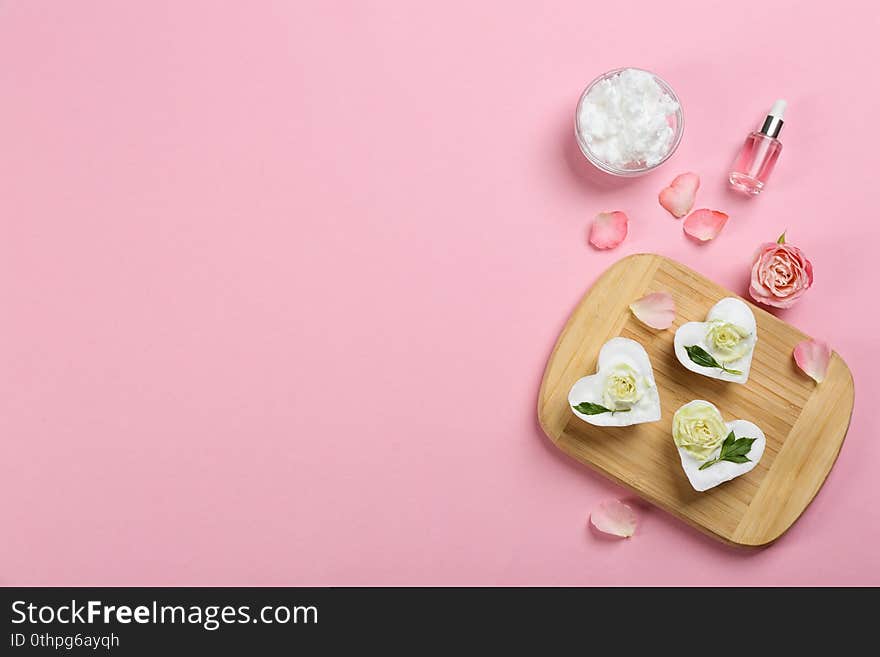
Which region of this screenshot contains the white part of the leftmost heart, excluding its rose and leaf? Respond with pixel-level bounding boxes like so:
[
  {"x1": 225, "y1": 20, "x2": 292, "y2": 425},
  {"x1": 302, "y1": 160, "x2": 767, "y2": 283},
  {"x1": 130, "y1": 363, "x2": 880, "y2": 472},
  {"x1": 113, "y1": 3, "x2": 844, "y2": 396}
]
[{"x1": 568, "y1": 338, "x2": 660, "y2": 427}]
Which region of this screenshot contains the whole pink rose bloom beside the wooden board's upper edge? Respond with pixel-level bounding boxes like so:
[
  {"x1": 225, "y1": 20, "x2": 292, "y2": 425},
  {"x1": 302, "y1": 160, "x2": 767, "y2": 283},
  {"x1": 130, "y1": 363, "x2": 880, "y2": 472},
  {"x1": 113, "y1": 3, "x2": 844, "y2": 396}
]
[{"x1": 749, "y1": 233, "x2": 813, "y2": 308}]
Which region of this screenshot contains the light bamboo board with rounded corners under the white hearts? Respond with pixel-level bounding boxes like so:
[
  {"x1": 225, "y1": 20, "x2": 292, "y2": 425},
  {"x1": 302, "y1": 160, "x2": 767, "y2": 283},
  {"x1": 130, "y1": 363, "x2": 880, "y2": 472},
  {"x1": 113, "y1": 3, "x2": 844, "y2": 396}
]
[{"x1": 538, "y1": 254, "x2": 854, "y2": 546}]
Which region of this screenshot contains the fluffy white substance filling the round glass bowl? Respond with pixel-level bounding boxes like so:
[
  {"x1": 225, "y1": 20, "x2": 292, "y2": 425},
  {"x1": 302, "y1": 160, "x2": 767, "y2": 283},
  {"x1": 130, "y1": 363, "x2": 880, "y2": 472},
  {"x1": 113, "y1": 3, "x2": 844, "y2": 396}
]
[{"x1": 577, "y1": 68, "x2": 678, "y2": 169}]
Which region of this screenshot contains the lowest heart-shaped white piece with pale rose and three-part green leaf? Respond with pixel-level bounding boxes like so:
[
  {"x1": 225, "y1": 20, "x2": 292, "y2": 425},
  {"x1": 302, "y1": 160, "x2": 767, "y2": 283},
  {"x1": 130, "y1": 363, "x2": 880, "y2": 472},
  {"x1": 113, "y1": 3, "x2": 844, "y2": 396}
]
[{"x1": 672, "y1": 399, "x2": 767, "y2": 492}]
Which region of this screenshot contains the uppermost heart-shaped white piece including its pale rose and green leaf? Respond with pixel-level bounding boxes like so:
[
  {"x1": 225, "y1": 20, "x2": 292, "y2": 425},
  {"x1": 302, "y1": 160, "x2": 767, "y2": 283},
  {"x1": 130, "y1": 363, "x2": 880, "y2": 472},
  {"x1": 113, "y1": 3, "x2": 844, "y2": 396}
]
[{"x1": 674, "y1": 297, "x2": 758, "y2": 383}]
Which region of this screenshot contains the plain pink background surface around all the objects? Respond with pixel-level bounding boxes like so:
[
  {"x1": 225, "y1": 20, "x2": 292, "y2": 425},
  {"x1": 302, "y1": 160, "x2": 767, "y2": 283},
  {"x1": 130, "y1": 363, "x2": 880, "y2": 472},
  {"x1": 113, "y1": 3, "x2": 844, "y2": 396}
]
[{"x1": 0, "y1": 0, "x2": 880, "y2": 585}]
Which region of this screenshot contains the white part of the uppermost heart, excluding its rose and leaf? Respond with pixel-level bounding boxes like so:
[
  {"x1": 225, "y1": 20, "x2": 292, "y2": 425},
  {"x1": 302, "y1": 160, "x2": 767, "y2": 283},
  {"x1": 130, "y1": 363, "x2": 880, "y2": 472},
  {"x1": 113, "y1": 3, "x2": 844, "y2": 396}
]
[{"x1": 675, "y1": 297, "x2": 758, "y2": 383}]
